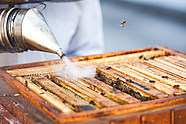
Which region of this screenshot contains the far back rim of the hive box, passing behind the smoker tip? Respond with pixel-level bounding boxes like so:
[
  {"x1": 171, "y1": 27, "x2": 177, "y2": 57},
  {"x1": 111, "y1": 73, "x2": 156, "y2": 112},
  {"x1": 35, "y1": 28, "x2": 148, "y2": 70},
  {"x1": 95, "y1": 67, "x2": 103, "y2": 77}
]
[{"x1": 0, "y1": 46, "x2": 169, "y2": 70}]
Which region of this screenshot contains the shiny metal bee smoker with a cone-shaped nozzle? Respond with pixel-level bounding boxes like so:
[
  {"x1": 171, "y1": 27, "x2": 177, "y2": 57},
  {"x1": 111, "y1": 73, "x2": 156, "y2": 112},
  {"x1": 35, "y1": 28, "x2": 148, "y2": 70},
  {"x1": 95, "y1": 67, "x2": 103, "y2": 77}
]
[{"x1": 0, "y1": 7, "x2": 64, "y2": 58}]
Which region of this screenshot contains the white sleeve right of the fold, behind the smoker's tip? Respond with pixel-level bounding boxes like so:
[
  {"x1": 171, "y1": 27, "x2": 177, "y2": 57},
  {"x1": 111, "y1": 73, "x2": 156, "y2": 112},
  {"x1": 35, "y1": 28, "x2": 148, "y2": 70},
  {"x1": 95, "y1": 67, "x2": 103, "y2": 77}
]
[{"x1": 66, "y1": 0, "x2": 104, "y2": 56}]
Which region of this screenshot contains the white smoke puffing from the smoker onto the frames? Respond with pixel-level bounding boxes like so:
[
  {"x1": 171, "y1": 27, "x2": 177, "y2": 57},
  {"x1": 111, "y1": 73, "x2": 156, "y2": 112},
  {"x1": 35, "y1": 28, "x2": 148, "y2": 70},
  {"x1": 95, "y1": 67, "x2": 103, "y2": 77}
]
[{"x1": 54, "y1": 56, "x2": 96, "y2": 81}]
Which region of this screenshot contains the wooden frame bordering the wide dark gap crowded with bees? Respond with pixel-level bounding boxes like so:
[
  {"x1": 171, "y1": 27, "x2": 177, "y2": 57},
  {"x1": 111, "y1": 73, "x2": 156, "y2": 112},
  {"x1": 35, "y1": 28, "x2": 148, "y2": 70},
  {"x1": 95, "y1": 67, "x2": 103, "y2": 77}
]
[{"x1": 97, "y1": 66, "x2": 164, "y2": 100}]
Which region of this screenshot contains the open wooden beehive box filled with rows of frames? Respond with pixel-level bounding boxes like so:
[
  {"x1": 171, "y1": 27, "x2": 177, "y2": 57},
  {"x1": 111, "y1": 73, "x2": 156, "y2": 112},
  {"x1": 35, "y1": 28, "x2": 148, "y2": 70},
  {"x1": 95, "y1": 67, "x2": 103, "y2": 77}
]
[{"x1": 0, "y1": 46, "x2": 186, "y2": 124}]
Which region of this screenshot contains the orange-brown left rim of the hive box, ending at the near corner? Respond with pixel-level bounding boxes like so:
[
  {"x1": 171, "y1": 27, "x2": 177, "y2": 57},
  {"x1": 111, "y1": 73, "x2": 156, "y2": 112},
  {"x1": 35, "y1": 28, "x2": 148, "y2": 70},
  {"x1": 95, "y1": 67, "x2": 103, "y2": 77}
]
[{"x1": 0, "y1": 70, "x2": 64, "y2": 122}]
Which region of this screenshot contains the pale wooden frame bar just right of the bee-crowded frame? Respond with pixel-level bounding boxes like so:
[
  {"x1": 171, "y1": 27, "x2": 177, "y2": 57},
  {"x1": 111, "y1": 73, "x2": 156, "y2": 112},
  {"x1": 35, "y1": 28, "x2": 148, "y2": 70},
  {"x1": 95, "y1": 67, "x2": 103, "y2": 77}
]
[{"x1": 112, "y1": 65, "x2": 182, "y2": 97}]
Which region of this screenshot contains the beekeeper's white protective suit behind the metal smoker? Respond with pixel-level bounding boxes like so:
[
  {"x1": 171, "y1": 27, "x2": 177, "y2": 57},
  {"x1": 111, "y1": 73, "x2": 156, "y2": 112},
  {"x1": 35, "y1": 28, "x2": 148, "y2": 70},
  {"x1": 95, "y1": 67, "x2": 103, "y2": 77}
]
[{"x1": 0, "y1": 0, "x2": 103, "y2": 66}]
